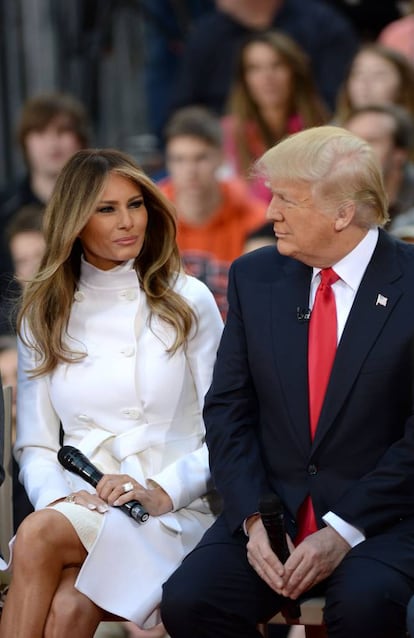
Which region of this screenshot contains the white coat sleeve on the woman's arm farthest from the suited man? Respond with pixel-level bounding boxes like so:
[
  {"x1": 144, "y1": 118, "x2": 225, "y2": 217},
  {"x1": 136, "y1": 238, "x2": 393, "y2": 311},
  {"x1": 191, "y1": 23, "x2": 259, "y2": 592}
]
[{"x1": 14, "y1": 340, "x2": 72, "y2": 509}]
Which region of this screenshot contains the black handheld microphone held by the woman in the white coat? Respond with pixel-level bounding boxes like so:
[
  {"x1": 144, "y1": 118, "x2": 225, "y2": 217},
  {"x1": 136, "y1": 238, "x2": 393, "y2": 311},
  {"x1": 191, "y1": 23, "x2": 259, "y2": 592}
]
[{"x1": 58, "y1": 445, "x2": 149, "y2": 523}]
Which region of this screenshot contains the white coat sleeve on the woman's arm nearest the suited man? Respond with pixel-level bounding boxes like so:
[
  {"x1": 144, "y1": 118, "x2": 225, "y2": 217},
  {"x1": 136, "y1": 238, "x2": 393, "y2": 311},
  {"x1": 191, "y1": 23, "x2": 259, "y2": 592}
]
[{"x1": 149, "y1": 282, "x2": 223, "y2": 510}]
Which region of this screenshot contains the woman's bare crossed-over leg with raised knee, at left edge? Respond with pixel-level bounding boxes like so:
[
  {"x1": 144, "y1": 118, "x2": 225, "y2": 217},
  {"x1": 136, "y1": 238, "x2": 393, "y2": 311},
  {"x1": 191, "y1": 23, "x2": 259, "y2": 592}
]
[{"x1": 0, "y1": 509, "x2": 87, "y2": 638}]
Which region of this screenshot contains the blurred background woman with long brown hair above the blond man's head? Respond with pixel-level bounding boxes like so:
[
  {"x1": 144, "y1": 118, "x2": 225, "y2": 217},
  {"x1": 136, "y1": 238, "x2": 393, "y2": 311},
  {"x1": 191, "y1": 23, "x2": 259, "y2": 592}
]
[{"x1": 222, "y1": 31, "x2": 328, "y2": 201}]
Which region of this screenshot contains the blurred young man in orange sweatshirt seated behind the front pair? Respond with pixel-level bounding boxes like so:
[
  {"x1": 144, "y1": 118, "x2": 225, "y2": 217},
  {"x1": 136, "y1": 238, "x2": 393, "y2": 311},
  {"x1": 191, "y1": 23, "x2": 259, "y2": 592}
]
[{"x1": 159, "y1": 106, "x2": 266, "y2": 317}]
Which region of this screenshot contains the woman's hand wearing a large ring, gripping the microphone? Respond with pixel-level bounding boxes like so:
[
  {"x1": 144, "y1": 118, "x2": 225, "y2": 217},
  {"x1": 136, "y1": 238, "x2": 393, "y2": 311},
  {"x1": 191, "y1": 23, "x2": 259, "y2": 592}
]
[{"x1": 96, "y1": 474, "x2": 173, "y2": 516}]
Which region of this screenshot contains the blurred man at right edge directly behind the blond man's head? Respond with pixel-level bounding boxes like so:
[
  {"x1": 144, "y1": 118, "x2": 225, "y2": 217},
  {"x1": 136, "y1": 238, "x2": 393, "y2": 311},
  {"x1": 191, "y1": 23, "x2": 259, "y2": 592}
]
[{"x1": 344, "y1": 104, "x2": 414, "y2": 230}]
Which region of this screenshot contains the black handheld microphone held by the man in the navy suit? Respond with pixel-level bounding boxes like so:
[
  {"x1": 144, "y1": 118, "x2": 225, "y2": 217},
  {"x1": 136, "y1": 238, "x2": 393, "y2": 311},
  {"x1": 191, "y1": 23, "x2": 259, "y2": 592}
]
[{"x1": 259, "y1": 493, "x2": 301, "y2": 618}]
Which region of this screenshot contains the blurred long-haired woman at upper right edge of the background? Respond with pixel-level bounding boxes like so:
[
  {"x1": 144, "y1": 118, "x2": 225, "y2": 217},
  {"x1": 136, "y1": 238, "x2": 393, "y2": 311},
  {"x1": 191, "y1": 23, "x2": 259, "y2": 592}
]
[{"x1": 334, "y1": 43, "x2": 414, "y2": 124}]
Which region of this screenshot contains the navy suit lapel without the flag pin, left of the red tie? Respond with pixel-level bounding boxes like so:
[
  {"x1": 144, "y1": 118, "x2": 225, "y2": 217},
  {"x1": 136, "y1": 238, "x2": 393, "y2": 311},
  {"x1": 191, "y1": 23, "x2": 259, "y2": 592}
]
[{"x1": 271, "y1": 260, "x2": 312, "y2": 449}]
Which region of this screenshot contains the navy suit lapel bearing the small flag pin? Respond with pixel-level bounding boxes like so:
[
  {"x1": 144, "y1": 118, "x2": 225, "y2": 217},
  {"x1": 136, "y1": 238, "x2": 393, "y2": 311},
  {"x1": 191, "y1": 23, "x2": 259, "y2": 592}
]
[{"x1": 313, "y1": 231, "x2": 402, "y2": 449}]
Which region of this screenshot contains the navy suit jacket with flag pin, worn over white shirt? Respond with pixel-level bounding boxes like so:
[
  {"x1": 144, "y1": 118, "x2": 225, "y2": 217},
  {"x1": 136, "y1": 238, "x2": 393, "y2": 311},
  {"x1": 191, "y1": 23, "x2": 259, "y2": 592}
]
[{"x1": 205, "y1": 231, "x2": 414, "y2": 570}]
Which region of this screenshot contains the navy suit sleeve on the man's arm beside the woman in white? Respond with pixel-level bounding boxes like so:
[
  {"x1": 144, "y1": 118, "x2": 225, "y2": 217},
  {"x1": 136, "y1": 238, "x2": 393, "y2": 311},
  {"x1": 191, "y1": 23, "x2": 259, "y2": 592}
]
[{"x1": 204, "y1": 262, "x2": 270, "y2": 532}]
